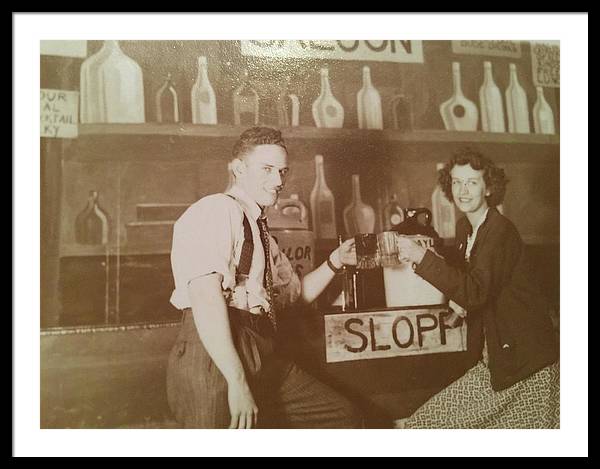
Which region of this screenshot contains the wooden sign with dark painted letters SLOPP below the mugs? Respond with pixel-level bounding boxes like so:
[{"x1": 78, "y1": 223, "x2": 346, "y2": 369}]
[{"x1": 325, "y1": 307, "x2": 467, "y2": 363}]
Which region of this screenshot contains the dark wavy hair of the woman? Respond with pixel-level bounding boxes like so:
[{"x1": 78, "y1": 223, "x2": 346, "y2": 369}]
[{"x1": 438, "y1": 147, "x2": 508, "y2": 207}]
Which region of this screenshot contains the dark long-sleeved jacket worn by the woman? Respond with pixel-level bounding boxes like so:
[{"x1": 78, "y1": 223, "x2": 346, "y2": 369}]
[{"x1": 415, "y1": 208, "x2": 558, "y2": 391}]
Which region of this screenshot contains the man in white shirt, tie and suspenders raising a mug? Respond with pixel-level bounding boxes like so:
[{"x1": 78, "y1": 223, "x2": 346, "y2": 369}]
[{"x1": 167, "y1": 127, "x2": 358, "y2": 428}]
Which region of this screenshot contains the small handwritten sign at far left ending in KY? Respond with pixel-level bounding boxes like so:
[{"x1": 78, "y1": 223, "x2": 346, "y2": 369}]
[{"x1": 40, "y1": 90, "x2": 79, "y2": 138}]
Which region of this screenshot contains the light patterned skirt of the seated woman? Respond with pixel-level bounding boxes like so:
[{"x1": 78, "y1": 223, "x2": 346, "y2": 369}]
[{"x1": 396, "y1": 361, "x2": 560, "y2": 428}]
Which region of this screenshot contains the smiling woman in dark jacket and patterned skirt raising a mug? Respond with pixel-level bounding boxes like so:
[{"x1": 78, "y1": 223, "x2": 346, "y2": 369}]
[{"x1": 398, "y1": 149, "x2": 559, "y2": 428}]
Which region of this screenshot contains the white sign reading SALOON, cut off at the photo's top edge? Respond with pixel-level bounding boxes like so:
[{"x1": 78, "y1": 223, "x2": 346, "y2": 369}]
[{"x1": 240, "y1": 40, "x2": 423, "y2": 63}]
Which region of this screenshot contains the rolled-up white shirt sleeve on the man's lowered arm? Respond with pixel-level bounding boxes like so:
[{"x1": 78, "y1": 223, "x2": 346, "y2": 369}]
[{"x1": 171, "y1": 194, "x2": 243, "y2": 309}]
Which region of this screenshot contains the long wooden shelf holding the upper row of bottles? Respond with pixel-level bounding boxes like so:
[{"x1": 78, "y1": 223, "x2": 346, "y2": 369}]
[{"x1": 79, "y1": 123, "x2": 560, "y2": 145}]
